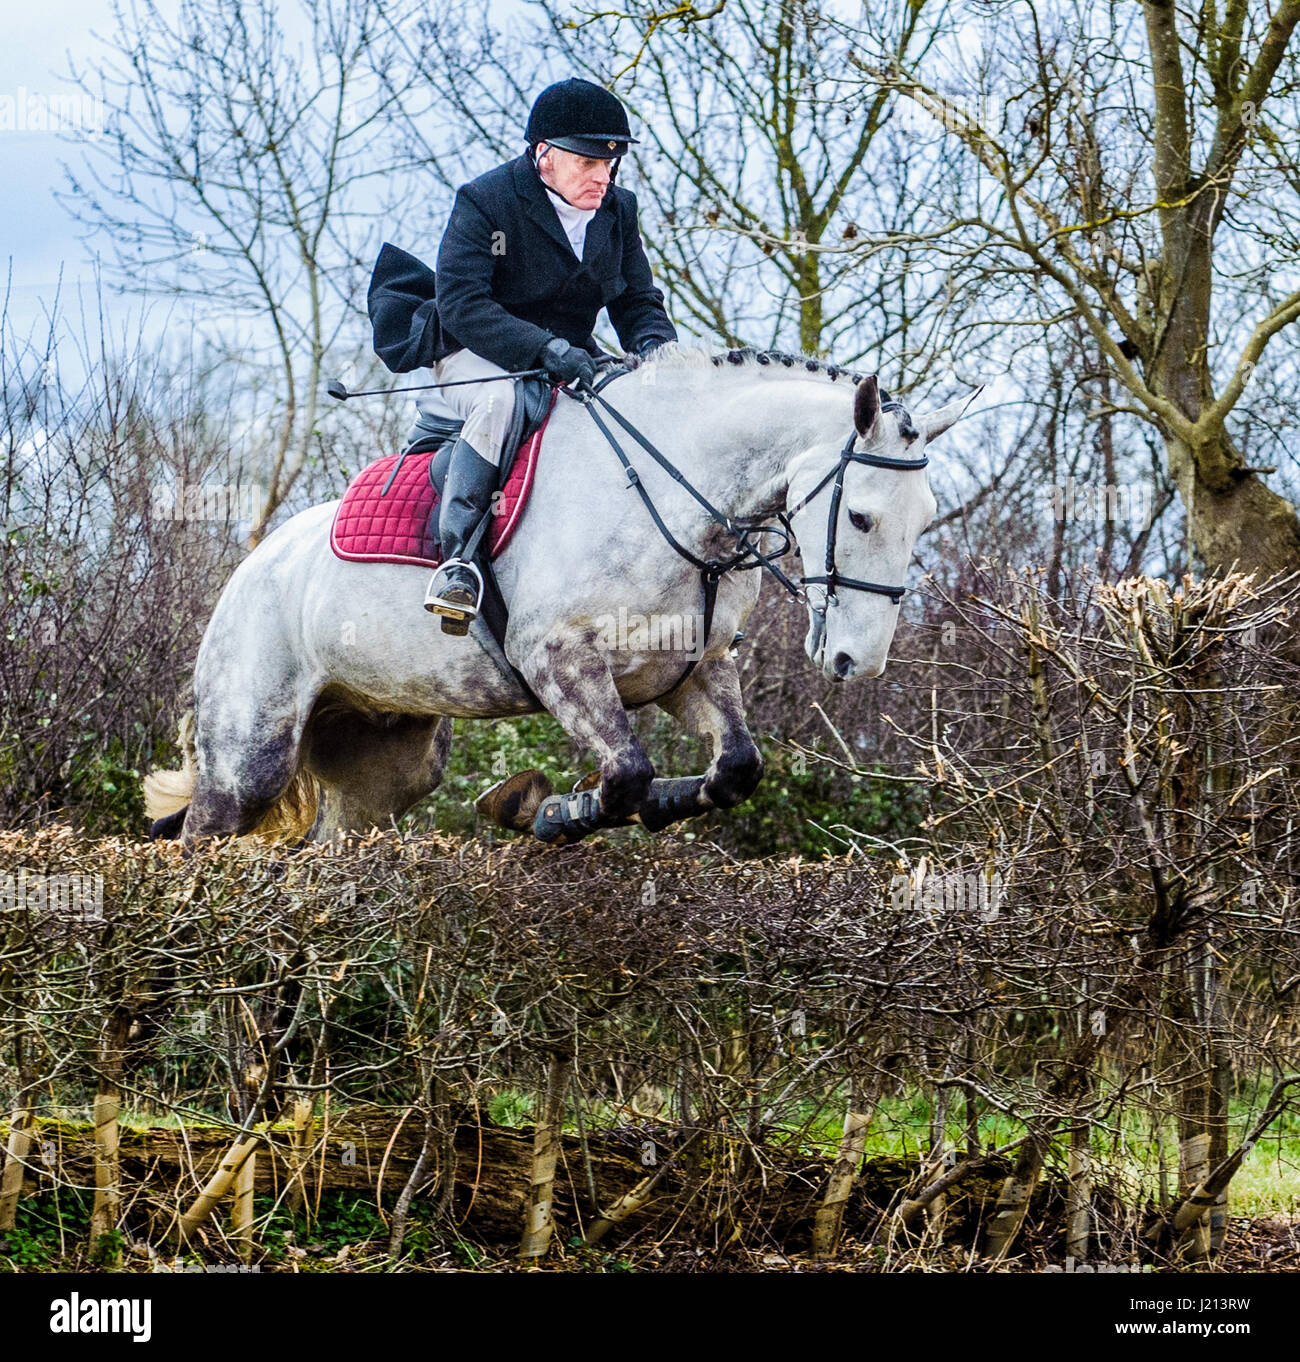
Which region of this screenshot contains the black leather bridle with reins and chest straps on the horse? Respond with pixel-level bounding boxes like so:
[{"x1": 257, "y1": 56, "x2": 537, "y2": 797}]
[{"x1": 560, "y1": 369, "x2": 929, "y2": 704}]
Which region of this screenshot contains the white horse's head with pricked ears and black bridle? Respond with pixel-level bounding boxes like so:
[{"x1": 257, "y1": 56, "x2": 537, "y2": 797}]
[{"x1": 786, "y1": 375, "x2": 978, "y2": 681}]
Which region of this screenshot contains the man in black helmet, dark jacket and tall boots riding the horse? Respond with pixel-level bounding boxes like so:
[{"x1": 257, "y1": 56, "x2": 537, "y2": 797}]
[{"x1": 422, "y1": 78, "x2": 677, "y2": 633}]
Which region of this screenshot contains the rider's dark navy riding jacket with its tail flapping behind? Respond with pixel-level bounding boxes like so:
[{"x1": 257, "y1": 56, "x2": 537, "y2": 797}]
[{"x1": 368, "y1": 155, "x2": 677, "y2": 373}]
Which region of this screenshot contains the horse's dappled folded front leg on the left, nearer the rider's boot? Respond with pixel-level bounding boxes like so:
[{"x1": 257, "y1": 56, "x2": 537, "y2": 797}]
[{"x1": 519, "y1": 635, "x2": 654, "y2": 843}]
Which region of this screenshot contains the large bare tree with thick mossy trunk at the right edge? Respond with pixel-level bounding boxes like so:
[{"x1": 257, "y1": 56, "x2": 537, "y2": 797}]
[{"x1": 854, "y1": 0, "x2": 1300, "y2": 571}]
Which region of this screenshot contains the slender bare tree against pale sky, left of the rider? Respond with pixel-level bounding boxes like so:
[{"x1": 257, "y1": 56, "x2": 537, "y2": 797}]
[{"x1": 65, "y1": 0, "x2": 414, "y2": 542}]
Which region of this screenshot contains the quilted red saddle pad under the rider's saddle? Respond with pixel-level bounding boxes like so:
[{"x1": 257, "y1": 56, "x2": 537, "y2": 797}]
[{"x1": 330, "y1": 391, "x2": 555, "y2": 568}]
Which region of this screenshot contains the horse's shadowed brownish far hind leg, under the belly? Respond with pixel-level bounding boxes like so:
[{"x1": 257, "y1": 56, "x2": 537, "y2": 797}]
[{"x1": 303, "y1": 708, "x2": 451, "y2": 842}]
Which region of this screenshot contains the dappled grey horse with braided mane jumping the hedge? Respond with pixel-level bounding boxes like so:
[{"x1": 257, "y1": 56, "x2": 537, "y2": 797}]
[{"x1": 144, "y1": 345, "x2": 978, "y2": 844}]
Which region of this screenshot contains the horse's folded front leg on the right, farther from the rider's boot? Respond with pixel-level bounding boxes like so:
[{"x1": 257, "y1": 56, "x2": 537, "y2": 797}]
[{"x1": 640, "y1": 652, "x2": 763, "y2": 827}]
